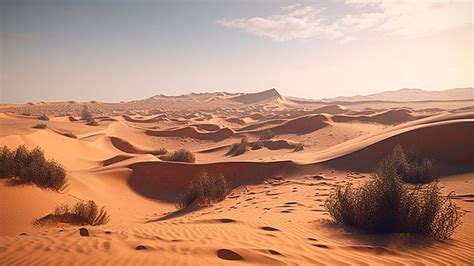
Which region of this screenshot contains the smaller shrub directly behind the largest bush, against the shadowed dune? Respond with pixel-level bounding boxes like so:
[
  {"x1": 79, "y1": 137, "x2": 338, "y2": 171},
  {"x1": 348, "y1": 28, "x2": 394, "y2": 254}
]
[{"x1": 376, "y1": 145, "x2": 436, "y2": 184}]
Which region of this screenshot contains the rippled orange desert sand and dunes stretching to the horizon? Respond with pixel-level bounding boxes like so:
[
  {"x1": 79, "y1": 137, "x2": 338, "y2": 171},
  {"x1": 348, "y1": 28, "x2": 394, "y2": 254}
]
[{"x1": 0, "y1": 88, "x2": 474, "y2": 265}]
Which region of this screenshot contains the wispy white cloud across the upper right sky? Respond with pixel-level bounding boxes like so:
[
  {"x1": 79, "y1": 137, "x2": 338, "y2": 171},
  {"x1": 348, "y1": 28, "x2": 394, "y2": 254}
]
[{"x1": 216, "y1": 0, "x2": 472, "y2": 43}]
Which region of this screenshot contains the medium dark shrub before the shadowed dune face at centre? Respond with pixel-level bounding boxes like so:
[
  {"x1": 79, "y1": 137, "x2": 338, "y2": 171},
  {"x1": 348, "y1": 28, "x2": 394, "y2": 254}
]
[{"x1": 176, "y1": 171, "x2": 230, "y2": 209}]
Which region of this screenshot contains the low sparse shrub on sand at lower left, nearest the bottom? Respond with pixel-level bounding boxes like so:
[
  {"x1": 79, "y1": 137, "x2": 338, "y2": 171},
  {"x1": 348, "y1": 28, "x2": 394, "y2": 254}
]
[{"x1": 35, "y1": 200, "x2": 110, "y2": 226}]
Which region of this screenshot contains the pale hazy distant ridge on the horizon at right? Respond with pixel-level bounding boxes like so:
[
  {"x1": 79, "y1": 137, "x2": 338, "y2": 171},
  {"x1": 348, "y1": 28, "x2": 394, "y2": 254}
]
[{"x1": 322, "y1": 88, "x2": 474, "y2": 102}]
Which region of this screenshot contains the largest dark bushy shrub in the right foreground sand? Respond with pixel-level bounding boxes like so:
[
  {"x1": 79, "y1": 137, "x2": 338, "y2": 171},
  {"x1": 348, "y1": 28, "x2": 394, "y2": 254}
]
[{"x1": 325, "y1": 154, "x2": 461, "y2": 239}]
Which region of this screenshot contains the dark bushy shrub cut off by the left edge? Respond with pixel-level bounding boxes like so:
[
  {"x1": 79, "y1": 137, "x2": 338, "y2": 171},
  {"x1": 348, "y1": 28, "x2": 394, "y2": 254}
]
[{"x1": 0, "y1": 145, "x2": 67, "y2": 191}]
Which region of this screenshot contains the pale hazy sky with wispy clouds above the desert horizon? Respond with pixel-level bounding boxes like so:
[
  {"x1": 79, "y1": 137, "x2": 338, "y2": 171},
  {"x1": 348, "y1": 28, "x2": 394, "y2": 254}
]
[{"x1": 0, "y1": 0, "x2": 474, "y2": 103}]
